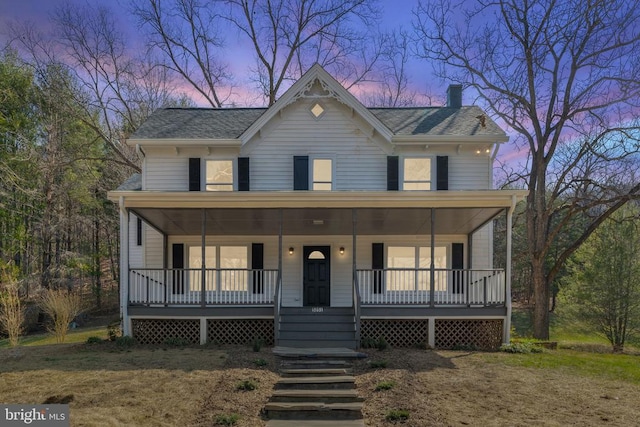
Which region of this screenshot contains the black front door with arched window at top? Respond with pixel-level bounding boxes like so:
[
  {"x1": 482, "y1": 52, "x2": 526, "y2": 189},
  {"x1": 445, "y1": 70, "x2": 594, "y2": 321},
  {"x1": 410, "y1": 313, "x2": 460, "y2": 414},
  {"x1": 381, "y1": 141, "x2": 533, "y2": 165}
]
[{"x1": 303, "y1": 246, "x2": 331, "y2": 307}]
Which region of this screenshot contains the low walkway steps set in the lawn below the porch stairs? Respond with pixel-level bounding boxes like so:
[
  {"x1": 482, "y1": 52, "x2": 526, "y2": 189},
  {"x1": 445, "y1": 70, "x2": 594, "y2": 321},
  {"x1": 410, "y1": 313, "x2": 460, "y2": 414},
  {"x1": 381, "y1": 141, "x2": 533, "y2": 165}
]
[{"x1": 264, "y1": 349, "x2": 364, "y2": 427}]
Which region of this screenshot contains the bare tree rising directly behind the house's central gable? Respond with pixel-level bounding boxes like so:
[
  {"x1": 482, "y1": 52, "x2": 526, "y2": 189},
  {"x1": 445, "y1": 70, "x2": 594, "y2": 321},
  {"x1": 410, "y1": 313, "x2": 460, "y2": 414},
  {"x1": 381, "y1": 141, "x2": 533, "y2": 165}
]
[{"x1": 222, "y1": 0, "x2": 380, "y2": 105}]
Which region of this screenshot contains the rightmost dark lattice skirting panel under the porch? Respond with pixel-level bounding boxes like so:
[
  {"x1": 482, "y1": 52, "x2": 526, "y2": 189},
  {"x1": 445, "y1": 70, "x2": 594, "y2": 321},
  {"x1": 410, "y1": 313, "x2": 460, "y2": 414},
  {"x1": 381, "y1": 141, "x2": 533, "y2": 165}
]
[{"x1": 435, "y1": 319, "x2": 503, "y2": 350}]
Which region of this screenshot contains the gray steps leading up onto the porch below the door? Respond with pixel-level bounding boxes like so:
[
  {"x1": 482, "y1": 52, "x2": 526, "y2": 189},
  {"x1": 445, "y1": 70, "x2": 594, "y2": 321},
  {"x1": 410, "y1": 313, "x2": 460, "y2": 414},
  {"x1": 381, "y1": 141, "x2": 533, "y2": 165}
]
[{"x1": 277, "y1": 307, "x2": 358, "y2": 349}]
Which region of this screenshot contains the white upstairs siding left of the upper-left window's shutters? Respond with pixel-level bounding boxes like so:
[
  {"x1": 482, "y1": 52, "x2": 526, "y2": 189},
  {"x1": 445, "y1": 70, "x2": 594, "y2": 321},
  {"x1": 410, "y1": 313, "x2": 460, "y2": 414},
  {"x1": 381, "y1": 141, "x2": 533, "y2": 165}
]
[{"x1": 142, "y1": 155, "x2": 189, "y2": 191}]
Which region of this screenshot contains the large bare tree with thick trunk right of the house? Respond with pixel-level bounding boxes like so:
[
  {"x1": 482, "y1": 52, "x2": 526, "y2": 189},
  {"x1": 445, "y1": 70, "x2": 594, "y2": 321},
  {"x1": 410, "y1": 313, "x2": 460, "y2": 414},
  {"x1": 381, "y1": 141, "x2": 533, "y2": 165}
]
[{"x1": 414, "y1": 0, "x2": 640, "y2": 339}]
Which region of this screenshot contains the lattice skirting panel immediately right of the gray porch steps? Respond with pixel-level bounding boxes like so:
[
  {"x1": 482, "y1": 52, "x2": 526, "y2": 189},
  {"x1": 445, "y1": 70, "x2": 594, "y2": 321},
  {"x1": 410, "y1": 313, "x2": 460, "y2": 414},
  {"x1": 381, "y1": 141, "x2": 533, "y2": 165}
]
[{"x1": 360, "y1": 319, "x2": 429, "y2": 348}]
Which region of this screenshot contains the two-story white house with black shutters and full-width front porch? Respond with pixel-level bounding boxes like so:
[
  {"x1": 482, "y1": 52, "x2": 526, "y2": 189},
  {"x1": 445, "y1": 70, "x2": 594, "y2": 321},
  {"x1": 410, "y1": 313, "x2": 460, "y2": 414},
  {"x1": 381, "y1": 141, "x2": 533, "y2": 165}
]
[{"x1": 109, "y1": 65, "x2": 525, "y2": 348}]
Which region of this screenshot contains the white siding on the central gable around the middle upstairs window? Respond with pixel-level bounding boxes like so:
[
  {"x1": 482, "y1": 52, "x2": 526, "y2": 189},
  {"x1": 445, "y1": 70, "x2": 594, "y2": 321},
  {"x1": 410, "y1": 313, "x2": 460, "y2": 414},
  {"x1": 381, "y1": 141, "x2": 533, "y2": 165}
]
[{"x1": 243, "y1": 99, "x2": 387, "y2": 191}]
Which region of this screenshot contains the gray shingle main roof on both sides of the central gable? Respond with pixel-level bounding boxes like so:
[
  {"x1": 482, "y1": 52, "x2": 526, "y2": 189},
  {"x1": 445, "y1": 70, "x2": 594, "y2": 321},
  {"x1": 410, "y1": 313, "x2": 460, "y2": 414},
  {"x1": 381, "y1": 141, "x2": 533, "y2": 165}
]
[{"x1": 131, "y1": 106, "x2": 504, "y2": 139}]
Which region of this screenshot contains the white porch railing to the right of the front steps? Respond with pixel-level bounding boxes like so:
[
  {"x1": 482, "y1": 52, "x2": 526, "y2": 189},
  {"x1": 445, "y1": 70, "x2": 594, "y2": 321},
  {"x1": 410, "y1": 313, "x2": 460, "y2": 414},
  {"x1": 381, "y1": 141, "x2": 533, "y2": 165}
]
[{"x1": 357, "y1": 268, "x2": 505, "y2": 306}]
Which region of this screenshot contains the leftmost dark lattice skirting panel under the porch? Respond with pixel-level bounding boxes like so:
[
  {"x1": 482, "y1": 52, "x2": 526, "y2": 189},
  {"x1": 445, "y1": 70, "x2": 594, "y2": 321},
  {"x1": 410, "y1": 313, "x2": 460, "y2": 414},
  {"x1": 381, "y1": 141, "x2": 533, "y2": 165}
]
[{"x1": 131, "y1": 319, "x2": 200, "y2": 344}]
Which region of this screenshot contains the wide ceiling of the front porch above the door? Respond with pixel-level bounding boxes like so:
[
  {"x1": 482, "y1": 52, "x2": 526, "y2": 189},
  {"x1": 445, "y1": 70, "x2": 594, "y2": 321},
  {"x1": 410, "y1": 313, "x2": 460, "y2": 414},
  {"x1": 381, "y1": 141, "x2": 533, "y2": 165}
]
[{"x1": 131, "y1": 207, "x2": 505, "y2": 236}]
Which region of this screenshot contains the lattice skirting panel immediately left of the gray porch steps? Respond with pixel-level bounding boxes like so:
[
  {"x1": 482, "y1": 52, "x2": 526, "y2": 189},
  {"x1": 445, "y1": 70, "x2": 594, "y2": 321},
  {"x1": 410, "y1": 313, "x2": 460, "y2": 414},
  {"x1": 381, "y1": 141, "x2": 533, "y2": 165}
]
[{"x1": 207, "y1": 319, "x2": 273, "y2": 345}]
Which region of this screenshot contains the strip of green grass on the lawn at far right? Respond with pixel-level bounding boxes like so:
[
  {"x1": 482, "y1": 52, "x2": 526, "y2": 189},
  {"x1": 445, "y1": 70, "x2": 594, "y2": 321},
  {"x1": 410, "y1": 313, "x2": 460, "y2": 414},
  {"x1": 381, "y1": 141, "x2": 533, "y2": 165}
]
[{"x1": 485, "y1": 350, "x2": 640, "y2": 384}]
